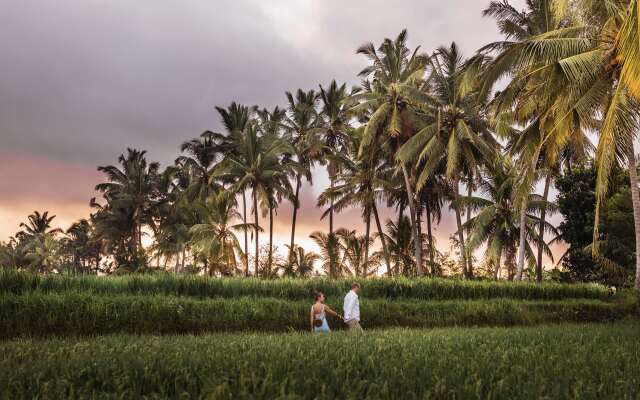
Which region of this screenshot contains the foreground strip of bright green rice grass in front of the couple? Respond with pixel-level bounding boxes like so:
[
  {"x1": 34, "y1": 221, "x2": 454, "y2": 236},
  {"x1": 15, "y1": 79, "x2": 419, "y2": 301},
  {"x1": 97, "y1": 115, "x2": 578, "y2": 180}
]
[{"x1": 0, "y1": 322, "x2": 640, "y2": 400}]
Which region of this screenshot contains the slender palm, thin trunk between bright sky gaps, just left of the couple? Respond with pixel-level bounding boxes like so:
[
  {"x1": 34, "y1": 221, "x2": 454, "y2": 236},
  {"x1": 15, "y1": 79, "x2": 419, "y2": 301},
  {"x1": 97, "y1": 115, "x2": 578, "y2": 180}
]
[{"x1": 284, "y1": 89, "x2": 324, "y2": 261}]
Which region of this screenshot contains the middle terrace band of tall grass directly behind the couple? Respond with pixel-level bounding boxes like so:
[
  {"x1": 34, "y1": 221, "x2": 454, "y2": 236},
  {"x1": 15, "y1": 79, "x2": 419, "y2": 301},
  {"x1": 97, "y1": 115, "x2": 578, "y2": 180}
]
[{"x1": 0, "y1": 292, "x2": 638, "y2": 338}]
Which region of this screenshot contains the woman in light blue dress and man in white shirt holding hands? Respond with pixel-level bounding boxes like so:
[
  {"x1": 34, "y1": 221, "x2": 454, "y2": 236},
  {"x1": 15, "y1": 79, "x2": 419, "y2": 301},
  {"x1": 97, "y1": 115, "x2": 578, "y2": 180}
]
[{"x1": 311, "y1": 283, "x2": 362, "y2": 333}]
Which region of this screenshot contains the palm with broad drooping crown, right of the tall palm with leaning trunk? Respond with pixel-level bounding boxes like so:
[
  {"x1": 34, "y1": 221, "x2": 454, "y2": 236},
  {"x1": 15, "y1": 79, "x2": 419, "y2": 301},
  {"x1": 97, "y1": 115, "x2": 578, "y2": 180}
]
[{"x1": 398, "y1": 43, "x2": 499, "y2": 278}]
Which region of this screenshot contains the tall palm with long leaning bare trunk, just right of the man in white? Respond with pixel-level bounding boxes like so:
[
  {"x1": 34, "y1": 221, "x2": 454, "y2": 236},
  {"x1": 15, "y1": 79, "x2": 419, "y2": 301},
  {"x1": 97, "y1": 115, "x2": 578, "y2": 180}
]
[{"x1": 354, "y1": 30, "x2": 428, "y2": 275}]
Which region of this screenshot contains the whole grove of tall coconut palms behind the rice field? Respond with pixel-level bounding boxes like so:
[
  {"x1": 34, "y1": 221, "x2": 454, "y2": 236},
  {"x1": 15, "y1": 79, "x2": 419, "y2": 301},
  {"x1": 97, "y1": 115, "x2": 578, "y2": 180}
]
[{"x1": 4, "y1": 0, "x2": 640, "y2": 289}]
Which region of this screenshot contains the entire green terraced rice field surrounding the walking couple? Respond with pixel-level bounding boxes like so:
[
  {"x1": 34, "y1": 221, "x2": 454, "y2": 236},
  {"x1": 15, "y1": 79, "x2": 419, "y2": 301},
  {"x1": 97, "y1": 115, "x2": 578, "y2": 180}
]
[{"x1": 0, "y1": 272, "x2": 640, "y2": 399}]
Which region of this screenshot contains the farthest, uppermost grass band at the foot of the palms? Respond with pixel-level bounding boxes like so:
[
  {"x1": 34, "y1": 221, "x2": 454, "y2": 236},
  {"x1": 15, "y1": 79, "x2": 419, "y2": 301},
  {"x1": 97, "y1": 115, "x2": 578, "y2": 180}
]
[{"x1": 0, "y1": 271, "x2": 609, "y2": 300}]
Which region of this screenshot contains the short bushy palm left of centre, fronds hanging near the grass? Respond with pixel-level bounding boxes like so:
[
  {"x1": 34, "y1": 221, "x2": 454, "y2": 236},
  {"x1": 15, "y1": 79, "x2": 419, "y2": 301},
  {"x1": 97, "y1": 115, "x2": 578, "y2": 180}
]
[{"x1": 189, "y1": 192, "x2": 244, "y2": 275}]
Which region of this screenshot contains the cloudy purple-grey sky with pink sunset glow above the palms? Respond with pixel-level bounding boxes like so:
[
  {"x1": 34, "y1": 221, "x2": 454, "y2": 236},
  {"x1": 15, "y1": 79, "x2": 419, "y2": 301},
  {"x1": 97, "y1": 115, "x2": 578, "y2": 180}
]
[{"x1": 0, "y1": 0, "x2": 556, "y2": 264}]
